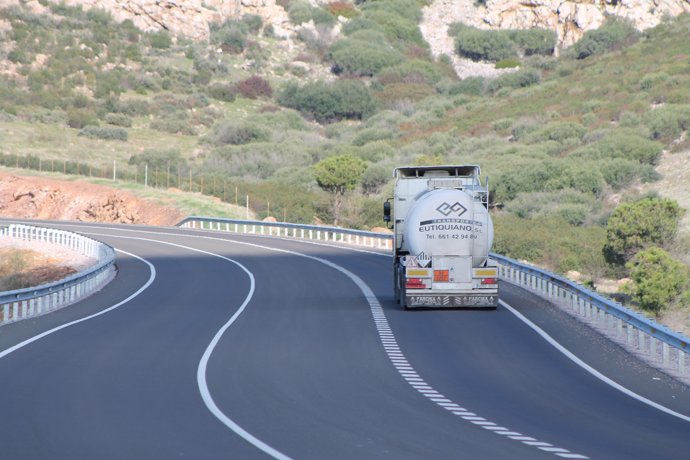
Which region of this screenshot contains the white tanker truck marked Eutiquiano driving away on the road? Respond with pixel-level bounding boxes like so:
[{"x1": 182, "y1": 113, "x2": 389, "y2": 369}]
[{"x1": 383, "y1": 165, "x2": 498, "y2": 309}]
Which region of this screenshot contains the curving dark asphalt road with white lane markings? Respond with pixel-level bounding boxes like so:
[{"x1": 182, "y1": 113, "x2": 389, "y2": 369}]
[{"x1": 0, "y1": 223, "x2": 690, "y2": 460}]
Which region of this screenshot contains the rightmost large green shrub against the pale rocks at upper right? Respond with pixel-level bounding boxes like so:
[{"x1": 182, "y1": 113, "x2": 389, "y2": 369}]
[{"x1": 569, "y1": 18, "x2": 639, "y2": 59}]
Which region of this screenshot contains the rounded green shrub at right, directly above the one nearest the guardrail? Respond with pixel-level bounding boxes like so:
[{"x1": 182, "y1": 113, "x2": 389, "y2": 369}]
[{"x1": 604, "y1": 198, "x2": 684, "y2": 265}]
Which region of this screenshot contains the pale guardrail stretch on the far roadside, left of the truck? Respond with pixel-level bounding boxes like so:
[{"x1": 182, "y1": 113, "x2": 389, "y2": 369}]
[{"x1": 177, "y1": 216, "x2": 393, "y2": 251}]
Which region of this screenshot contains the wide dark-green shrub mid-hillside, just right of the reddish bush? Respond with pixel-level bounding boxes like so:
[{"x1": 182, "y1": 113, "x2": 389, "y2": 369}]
[{"x1": 277, "y1": 80, "x2": 376, "y2": 123}]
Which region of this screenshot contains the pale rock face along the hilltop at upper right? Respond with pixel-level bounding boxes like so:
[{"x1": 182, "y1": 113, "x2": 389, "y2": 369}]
[{"x1": 421, "y1": 0, "x2": 690, "y2": 62}]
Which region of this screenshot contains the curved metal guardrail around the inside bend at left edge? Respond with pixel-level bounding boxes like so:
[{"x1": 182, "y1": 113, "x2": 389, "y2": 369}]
[{"x1": 0, "y1": 224, "x2": 115, "y2": 326}]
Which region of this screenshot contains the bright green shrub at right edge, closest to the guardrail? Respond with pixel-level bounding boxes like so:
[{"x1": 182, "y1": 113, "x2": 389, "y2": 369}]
[{"x1": 626, "y1": 248, "x2": 690, "y2": 314}]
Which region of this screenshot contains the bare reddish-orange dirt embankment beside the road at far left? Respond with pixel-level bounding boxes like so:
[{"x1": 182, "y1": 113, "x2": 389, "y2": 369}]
[{"x1": 0, "y1": 172, "x2": 184, "y2": 226}]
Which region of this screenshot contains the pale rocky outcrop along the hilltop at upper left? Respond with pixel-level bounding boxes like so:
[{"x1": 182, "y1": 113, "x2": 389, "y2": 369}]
[{"x1": 59, "y1": 0, "x2": 288, "y2": 40}]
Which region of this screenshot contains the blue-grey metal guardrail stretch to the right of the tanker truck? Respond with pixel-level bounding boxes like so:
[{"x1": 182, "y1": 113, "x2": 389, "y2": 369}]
[{"x1": 491, "y1": 254, "x2": 690, "y2": 385}]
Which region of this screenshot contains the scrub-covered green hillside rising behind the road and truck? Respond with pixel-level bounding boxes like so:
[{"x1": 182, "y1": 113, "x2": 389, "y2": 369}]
[{"x1": 0, "y1": 0, "x2": 690, "y2": 330}]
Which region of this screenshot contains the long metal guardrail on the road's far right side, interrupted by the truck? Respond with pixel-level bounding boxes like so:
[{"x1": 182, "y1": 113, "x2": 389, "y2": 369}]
[{"x1": 177, "y1": 216, "x2": 690, "y2": 383}]
